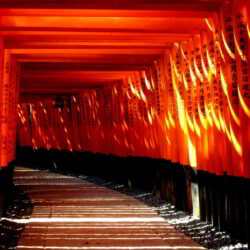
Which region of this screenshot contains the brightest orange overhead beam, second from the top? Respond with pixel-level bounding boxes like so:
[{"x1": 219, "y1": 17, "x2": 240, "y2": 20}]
[{"x1": 1, "y1": 16, "x2": 207, "y2": 33}]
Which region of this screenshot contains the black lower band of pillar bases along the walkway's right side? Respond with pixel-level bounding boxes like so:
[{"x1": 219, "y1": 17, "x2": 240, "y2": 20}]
[{"x1": 16, "y1": 147, "x2": 250, "y2": 246}]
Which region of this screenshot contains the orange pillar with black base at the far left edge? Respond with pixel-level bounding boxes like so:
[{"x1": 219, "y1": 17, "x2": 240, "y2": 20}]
[{"x1": 0, "y1": 34, "x2": 18, "y2": 216}]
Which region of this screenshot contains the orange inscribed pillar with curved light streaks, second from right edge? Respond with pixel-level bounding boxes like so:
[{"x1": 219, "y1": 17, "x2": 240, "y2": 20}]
[{"x1": 221, "y1": 5, "x2": 244, "y2": 176}]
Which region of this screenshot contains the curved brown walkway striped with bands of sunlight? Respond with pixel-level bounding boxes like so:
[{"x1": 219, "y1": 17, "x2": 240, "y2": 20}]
[{"x1": 14, "y1": 167, "x2": 205, "y2": 250}]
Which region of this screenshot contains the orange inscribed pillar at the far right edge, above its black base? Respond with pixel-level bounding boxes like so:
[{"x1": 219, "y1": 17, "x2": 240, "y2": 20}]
[{"x1": 233, "y1": 0, "x2": 250, "y2": 178}]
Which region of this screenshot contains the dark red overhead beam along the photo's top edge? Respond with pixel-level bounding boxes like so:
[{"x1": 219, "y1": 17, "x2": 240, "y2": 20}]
[{"x1": 0, "y1": 0, "x2": 223, "y2": 11}]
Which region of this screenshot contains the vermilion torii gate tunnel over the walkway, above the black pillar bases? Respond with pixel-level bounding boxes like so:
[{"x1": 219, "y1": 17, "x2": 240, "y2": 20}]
[{"x1": 0, "y1": 0, "x2": 250, "y2": 245}]
